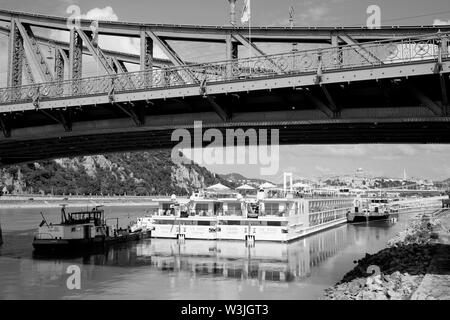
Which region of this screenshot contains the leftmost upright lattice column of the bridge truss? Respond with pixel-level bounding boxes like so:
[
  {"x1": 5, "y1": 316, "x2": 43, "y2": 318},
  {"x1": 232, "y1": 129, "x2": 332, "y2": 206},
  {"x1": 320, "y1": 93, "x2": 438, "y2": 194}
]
[{"x1": 7, "y1": 19, "x2": 25, "y2": 87}]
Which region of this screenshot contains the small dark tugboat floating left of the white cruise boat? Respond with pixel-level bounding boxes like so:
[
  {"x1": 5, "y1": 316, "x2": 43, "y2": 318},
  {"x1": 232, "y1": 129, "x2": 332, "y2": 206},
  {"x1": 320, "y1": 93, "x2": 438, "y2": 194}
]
[{"x1": 33, "y1": 205, "x2": 151, "y2": 253}]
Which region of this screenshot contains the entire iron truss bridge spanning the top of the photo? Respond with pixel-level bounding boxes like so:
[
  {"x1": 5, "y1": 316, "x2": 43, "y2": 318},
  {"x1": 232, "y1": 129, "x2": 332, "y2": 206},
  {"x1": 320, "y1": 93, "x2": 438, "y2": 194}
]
[{"x1": 0, "y1": 10, "x2": 450, "y2": 165}]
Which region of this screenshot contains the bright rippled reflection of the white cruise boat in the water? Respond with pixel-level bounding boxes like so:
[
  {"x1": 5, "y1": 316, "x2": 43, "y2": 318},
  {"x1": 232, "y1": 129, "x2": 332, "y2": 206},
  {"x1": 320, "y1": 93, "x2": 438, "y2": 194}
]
[{"x1": 73, "y1": 226, "x2": 348, "y2": 290}]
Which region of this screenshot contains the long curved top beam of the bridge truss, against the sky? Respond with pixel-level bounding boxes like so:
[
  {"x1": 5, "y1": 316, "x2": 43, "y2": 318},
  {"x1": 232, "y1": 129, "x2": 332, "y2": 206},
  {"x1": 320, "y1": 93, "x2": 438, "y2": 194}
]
[{"x1": 0, "y1": 10, "x2": 450, "y2": 43}]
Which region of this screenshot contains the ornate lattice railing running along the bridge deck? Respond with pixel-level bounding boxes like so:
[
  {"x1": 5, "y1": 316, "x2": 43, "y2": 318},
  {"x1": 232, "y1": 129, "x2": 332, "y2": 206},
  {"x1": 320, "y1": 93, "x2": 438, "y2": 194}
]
[{"x1": 0, "y1": 33, "x2": 450, "y2": 105}]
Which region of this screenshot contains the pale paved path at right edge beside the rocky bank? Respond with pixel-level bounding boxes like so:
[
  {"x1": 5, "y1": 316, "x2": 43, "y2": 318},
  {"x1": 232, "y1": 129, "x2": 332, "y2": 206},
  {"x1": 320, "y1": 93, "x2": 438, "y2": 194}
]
[{"x1": 411, "y1": 210, "x2": 450, "y2": 300}]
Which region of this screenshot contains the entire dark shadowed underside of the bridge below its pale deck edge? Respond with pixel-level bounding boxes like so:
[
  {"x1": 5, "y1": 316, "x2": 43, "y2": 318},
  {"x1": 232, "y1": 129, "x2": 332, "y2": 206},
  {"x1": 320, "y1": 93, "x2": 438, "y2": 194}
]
[{"x1": 0, "y1": 74, "x2": 450, "y2": 165}]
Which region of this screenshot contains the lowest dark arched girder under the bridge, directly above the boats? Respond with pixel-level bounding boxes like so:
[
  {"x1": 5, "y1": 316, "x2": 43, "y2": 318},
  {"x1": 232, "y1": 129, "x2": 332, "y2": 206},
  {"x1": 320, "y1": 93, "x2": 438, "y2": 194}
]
[{"x1": 0, "y1": 120, "x2": 450, "y2": 166}]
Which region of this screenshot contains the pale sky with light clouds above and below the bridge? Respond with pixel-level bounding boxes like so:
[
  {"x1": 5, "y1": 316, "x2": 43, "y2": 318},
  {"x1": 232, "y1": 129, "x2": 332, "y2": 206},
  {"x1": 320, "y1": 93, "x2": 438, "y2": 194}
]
[{"x1": 0, "y1": 0, "x2": 450, "y2": 181}]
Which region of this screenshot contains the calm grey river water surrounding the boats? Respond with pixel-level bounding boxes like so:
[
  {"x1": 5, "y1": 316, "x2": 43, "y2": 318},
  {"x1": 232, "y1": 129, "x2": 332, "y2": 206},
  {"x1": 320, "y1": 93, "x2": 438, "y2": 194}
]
[{"x1": 0, "y1": 207, "x2": 428, "y2": 299}]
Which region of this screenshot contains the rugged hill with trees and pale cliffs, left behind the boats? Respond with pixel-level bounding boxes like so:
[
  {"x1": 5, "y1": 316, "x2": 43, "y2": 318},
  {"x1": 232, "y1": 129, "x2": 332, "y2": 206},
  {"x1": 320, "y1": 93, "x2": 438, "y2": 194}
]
[{"x1": 0, "y1": 150, "x2": 238, "y2": 195}]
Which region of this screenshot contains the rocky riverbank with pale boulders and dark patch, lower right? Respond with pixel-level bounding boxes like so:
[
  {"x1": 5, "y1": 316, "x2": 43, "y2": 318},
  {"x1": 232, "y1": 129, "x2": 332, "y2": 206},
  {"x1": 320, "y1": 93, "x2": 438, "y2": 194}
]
[{"x1": 325, "y1": 215, "x2": 440, "y2": 300}]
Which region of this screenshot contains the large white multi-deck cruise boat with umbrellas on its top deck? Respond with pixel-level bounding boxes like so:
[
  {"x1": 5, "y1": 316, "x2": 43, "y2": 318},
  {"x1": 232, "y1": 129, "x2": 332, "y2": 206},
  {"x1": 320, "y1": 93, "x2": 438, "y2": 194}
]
[{"x1": 151, "y1": 189, "x2": 353, "y2": 242}]
